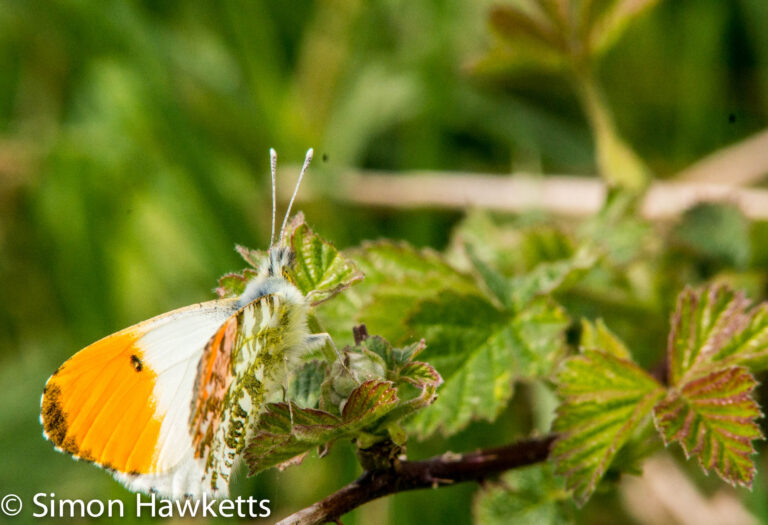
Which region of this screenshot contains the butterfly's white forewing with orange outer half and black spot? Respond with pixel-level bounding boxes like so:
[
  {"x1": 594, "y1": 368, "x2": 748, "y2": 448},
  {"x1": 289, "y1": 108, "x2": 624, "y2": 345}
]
[{"x1": 40, "y1": 299, "x2": 237, "y2": 497}]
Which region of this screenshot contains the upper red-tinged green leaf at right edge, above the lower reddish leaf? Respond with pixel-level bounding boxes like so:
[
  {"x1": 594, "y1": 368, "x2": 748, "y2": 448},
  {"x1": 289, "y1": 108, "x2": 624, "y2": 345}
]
[{"x1": 667, "y1": 284, "x2": 768, "y2": 386}]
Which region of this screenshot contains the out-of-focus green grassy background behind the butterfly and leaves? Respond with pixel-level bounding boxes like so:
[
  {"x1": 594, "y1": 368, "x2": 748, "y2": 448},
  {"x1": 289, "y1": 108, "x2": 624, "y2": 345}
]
[{"x1": 0, "y1": 0, "x2": 768, "y2": 525}]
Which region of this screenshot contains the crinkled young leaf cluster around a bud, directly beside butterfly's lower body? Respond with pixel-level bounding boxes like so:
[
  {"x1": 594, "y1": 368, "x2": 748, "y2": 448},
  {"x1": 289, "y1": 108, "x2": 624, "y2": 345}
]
[{"x1": 245, "y1": 336, "x2": 442, "y2": 474}]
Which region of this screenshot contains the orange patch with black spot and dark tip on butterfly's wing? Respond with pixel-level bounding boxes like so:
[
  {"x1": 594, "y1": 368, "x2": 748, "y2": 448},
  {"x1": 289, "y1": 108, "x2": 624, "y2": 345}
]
[{"x1": 42, "y1": 329, "x2": 160, "y2": 474}]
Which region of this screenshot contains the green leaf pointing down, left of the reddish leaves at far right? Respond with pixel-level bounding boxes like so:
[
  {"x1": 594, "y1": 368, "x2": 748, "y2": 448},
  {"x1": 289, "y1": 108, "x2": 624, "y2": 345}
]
[{"x1": 552, "y1": 345, "x2": 664, "y2": 505}]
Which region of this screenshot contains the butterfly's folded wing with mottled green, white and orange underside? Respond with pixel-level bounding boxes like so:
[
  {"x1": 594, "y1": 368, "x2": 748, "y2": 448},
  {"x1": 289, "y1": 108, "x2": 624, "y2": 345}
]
[{"x1": 190, "y1": 281, "x2": 308, "y2": 493}]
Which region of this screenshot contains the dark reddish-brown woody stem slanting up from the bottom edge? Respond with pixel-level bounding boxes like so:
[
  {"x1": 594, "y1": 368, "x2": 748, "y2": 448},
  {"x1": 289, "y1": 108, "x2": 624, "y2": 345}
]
[{"x1": 277, "y1": 435, "x2": 555, "y2": 525}]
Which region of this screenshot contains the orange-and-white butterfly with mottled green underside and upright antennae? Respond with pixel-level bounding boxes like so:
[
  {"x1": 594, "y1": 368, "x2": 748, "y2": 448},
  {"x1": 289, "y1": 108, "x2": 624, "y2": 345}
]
[{"x1": 40, "y1": 149, "x2": 332, "y2": 498}]
